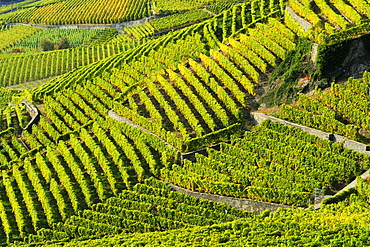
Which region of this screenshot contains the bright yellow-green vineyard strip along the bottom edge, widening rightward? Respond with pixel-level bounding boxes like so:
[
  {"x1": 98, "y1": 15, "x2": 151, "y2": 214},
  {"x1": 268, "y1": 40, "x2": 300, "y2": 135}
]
[{"x1": 28, "y1": 190, "x2": 369, "y2": 246}]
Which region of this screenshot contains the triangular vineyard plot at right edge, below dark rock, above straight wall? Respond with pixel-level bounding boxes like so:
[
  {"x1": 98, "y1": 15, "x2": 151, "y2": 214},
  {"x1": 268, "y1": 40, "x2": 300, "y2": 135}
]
[{"x1": 280, "y1": 72, "x2": 370, "y2": 140}]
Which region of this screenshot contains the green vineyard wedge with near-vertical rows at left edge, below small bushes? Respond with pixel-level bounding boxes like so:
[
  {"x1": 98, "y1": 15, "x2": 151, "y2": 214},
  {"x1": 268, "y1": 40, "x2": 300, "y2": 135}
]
[{"x1": 0, "y1": 44, "x2": 133, "y2": 86}]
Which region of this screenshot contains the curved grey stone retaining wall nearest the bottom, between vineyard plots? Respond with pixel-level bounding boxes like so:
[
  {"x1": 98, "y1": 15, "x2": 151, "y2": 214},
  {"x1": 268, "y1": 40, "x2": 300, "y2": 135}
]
[{"x1": 169, "y1": 184, "x2": 290, "y2": 214}]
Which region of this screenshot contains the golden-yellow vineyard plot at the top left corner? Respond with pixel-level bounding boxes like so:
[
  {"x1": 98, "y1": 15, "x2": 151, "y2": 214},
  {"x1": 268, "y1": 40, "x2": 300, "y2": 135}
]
[{"x1": 0, "y1": 0, "x2": 149, "y2": 25}]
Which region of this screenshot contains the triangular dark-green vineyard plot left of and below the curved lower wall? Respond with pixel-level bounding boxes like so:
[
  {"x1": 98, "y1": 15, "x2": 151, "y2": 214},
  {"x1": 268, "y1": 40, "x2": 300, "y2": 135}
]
[{"x1": 29, "y1": 179, "x2": 252, "y2": 242}]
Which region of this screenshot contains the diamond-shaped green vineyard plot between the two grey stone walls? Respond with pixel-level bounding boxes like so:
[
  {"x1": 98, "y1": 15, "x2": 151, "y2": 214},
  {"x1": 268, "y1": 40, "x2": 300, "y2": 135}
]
[{"x1": 161, "y1": 121, "x2": 369, "y2": 206}]
